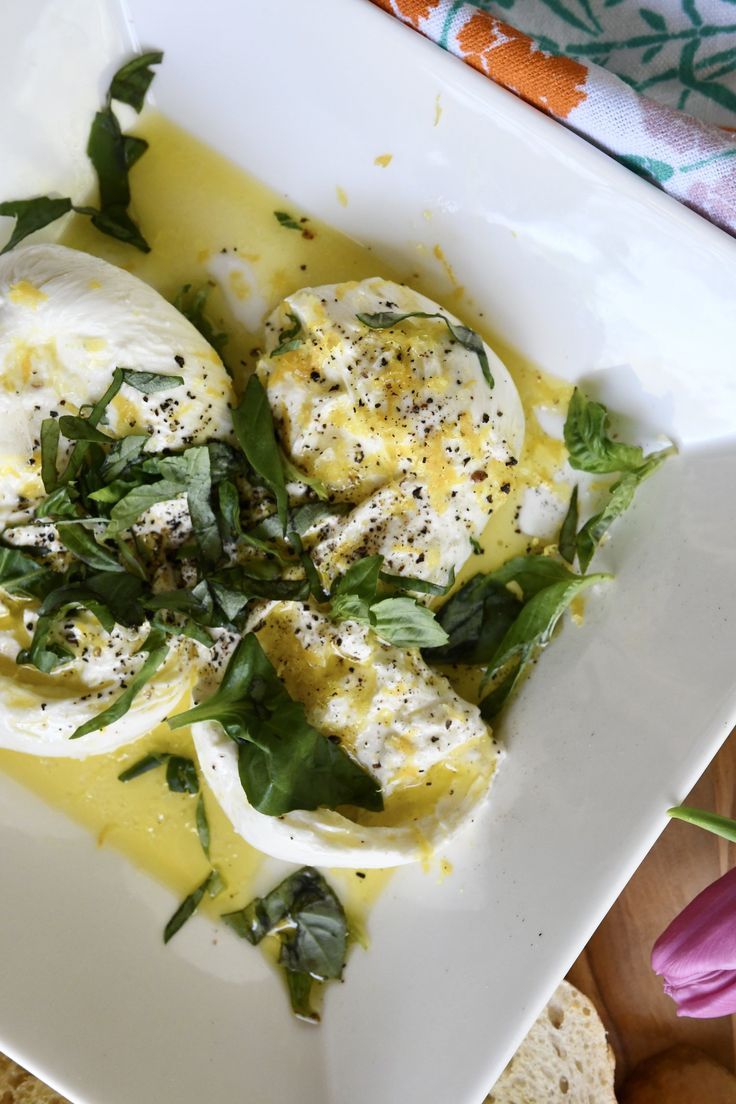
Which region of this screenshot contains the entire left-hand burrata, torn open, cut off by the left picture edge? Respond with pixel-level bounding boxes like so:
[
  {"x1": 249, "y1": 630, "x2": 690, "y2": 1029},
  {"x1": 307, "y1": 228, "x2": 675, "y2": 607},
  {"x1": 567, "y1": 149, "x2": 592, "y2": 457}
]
[{"x1": 0, "y1": 245, "x2": 234, "y2": 758}]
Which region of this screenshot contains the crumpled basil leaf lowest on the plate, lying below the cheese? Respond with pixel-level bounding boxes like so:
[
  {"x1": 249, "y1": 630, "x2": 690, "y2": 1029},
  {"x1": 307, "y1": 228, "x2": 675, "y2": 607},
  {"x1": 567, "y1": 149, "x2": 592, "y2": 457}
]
[{"x1": 222, "y1": 867, "x2": 348, "y2": 1022}]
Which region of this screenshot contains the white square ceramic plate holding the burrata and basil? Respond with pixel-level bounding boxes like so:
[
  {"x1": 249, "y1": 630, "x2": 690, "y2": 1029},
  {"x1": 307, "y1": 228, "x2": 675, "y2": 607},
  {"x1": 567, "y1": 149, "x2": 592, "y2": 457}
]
[{"x1": 0, "y1": 0, "x2": 736, "y2": 1104}]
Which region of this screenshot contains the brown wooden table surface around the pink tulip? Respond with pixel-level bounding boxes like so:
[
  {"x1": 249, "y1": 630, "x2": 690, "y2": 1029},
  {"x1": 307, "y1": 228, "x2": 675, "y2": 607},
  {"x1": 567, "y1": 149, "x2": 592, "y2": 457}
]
[{"x1": 568, "y1": 731, "x2": 736, "y2": 1084}]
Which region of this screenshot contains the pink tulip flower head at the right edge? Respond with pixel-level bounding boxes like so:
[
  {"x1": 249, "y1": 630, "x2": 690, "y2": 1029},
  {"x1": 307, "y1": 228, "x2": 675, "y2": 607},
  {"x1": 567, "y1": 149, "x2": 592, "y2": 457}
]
[{"x1": 652, "y1": 869, "x2": 736, "y2": 1019}]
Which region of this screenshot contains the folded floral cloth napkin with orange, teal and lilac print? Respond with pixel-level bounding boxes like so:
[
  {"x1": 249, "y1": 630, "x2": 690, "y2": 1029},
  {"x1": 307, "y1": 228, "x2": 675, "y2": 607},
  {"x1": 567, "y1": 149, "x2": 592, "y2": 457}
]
[{"x1": 373, "y1": 0, "x2": 736, "y2": 234}]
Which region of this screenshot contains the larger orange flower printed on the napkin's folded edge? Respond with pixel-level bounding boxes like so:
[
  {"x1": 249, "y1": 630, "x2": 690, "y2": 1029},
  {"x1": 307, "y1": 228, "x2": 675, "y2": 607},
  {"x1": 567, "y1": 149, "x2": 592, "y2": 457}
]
[{"x1": 457, "y1": 11, "x2": 588, "y2": 119}]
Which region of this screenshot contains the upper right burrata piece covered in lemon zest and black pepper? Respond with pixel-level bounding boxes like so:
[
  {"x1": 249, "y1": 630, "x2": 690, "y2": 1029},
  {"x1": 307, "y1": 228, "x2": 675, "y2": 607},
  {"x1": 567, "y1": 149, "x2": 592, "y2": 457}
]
[{"x1": 257, "y1": 277, "x2": 524, "y2": 583}]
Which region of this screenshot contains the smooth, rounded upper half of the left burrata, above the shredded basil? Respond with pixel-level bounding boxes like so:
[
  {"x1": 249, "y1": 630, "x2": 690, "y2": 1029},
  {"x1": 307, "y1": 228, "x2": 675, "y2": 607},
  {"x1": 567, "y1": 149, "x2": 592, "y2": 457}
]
[{"x1": 0, "y1": 245, "x2": 233, "y2": 524}]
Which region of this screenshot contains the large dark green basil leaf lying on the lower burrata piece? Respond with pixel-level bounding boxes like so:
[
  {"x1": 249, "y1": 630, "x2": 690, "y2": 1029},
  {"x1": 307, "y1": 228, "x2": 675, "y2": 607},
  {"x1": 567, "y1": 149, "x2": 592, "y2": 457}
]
[{"x1": 169, "y1": 633, "x2": 383, "y2": 816}]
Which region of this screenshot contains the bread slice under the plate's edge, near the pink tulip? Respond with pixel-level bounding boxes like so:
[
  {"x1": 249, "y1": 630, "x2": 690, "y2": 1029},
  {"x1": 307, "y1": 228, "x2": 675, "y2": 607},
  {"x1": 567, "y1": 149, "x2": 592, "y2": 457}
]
[{"x1": 486, "y1": 981, "x2": 616, "y2": 1104}]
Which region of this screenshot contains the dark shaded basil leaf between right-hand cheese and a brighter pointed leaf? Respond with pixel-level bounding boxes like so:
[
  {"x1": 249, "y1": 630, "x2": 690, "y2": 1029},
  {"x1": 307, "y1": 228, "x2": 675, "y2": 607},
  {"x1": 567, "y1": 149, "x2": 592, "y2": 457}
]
[{"x1": 424, "y1": 573, "x2": 522, "y2": 666}]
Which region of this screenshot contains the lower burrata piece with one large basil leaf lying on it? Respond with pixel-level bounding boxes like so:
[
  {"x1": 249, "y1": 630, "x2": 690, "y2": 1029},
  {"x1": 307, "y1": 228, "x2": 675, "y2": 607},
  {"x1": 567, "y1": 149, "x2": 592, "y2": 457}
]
[{"x1": 192, "y1": 602, "x2": 499, "y2": 868}]
